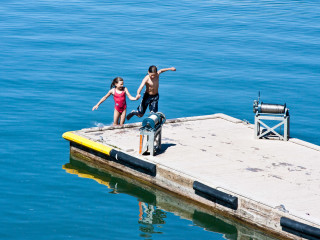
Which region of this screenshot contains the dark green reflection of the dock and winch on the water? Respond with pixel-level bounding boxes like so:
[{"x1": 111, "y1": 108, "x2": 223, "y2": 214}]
[{"x1": 63, "y1": 157, "x2": 274, "y2": 240}]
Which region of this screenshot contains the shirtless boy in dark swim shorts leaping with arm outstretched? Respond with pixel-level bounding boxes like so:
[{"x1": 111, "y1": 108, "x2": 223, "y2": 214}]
[{"x1": 127, "y1": 65, "x2": 176, "y2": 120}]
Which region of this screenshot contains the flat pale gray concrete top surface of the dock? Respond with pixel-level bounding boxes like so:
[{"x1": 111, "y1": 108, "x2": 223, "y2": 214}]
[{"x1": 74, "y1": 114, "x2": 320, "y2": 239}]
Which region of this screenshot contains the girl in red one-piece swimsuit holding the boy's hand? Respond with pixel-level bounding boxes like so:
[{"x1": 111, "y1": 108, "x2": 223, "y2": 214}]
[{"x1": 92, "y1": 77, "x2": 138, "y2": 126}]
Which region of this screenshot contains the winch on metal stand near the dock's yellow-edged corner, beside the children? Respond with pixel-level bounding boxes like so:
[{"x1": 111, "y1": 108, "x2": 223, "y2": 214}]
[{"x1": 139, "y1": 112, "x2": 166, "y2": 156}]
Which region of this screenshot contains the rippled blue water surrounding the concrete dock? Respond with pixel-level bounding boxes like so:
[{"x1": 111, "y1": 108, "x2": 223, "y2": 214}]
[{"x1": 0, "y1": 0, "x2": 320, "y2": 239}]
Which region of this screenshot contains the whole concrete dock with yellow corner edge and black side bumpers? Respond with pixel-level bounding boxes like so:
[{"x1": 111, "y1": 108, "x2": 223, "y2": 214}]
[{"x1": 63, "y1": 114, "x2": 320, "y2": 239}]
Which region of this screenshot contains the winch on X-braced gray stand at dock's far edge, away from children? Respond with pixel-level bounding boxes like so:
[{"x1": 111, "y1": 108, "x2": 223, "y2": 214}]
[{"x1": 253, "y1": 92, "x2": 290, "y2": 141}]
